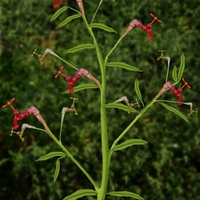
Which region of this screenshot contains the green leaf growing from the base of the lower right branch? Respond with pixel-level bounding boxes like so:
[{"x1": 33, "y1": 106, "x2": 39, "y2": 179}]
[{"x1": 111, "y1": 139, "x2": 147, "y2": 151}]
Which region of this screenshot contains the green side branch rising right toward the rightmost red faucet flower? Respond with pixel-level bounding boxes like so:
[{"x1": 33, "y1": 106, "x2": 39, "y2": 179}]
[{"x1": 110, "y1": 99, "x2": 156, "y2": 152}]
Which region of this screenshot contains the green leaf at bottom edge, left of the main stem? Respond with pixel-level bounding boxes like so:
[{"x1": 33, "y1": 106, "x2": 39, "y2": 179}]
[{"x1": 63, "y1": 189, "x2": 97, "y2": 200}]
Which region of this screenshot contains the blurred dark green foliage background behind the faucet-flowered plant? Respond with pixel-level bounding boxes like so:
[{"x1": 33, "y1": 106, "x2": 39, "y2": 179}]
[{"x1": 0, "y1": 0, "x2": 200, "y2": 200}]
